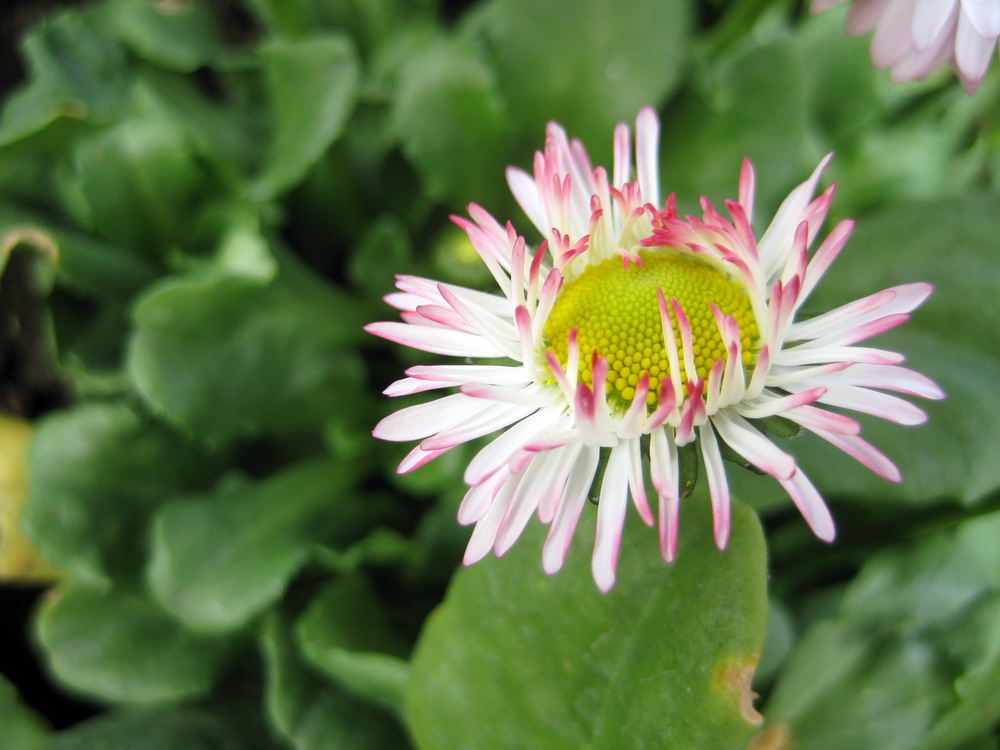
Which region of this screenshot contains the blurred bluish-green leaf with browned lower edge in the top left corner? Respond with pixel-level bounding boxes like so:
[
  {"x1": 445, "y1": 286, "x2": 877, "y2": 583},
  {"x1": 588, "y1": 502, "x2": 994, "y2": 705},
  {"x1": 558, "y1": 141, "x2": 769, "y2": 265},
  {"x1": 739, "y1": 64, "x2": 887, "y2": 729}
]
[{"x1": 0, "y1": 11, "x2": 129, "y2": 147}]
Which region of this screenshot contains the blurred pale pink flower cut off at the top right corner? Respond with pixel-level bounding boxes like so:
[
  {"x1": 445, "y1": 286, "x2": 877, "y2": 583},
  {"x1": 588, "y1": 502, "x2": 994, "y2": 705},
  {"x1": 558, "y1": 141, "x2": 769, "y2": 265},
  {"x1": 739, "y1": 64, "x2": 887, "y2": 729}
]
[{"x1": 812, "y1": 0, "x2": 1000, "y2": 94}]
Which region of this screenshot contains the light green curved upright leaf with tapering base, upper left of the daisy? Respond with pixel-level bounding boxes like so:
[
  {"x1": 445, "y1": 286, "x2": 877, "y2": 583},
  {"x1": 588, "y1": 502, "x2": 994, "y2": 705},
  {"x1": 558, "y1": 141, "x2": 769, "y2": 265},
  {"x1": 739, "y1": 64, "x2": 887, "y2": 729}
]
[{"x1": 253, "y1": 35, "x2": 360, "y2": 198}]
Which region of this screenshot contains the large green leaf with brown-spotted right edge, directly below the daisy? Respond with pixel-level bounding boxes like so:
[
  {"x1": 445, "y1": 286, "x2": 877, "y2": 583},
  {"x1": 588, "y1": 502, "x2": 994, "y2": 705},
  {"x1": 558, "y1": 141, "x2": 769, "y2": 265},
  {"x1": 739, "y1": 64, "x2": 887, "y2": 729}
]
[{"x1": 406, "y1": 498, "x2": 767, "y2": 750}]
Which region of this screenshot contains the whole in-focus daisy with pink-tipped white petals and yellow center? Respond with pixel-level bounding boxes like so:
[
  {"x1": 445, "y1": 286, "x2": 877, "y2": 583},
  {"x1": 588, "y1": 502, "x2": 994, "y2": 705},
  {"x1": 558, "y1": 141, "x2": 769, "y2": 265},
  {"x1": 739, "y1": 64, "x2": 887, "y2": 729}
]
[{"x1": 366, "y1": 108, "x2": 943, "y2": 591}]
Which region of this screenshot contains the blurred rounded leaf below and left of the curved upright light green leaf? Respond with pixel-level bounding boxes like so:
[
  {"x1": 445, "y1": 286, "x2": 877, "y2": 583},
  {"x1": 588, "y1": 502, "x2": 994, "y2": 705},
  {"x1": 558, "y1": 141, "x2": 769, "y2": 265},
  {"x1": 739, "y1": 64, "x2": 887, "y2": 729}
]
[{"x1": 63, "y1": 115, "x2": 209, "y2": 258}]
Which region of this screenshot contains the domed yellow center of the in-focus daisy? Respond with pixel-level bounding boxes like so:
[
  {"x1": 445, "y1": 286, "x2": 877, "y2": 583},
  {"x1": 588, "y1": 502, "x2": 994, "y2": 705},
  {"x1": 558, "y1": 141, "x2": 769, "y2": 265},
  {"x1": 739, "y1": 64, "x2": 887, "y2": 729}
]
[{"x1": 544, "y1": 248, "x2": 760, "y2": 408}]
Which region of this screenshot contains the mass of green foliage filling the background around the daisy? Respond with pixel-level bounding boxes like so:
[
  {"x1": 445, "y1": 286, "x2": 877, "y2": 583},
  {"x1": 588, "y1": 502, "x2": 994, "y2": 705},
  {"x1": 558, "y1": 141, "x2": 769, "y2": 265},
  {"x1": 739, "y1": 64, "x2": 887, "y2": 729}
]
[{"x1": 0, "y1": 0, "x2": 1000, "y2": 750}]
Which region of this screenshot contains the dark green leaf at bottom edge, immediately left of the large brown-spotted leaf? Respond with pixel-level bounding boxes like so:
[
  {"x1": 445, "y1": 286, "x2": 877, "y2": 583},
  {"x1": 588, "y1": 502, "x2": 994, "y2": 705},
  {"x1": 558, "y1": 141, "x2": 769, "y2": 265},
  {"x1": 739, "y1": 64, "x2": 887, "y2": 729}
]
[{"x1": 261, "y1": 615, "x2": 409, "y2": 750}]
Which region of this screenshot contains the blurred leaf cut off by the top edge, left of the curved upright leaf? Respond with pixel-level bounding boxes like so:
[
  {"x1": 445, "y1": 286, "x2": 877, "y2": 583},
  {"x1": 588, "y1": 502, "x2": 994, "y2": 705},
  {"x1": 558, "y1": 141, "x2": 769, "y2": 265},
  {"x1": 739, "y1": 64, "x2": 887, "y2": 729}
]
[{"x1": 98, "y1": 0, "x2": 238, "y2": 73}]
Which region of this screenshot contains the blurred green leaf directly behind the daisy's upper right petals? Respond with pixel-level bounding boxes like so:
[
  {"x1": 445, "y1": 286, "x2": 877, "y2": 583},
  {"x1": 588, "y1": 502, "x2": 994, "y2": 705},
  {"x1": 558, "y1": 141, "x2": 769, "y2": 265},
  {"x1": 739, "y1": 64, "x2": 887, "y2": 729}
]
[{"x1": 661, "y1": 36, "x2": 805, "y2": 217}]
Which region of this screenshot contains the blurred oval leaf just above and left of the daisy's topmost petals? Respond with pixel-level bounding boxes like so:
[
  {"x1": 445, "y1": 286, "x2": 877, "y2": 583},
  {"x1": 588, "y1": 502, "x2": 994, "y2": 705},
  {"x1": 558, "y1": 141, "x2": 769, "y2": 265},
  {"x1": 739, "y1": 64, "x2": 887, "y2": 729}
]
[{"x1": 392, "y1": 41, "x2": 509, "y2": 206}]
